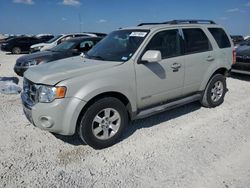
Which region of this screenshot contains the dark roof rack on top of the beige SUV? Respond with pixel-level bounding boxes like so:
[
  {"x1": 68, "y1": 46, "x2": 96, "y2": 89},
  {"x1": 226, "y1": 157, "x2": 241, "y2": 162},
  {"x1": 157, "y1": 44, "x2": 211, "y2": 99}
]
[{"x1": 138, "y1": 20, "x2": 216, "y2": 26}]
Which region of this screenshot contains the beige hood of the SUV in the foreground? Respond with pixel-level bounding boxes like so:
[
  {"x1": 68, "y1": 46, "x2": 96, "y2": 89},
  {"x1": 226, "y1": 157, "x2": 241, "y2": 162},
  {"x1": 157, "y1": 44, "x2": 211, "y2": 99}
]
[{"x1": 24, "y1": 56, "x2": 123, "y2": 85}]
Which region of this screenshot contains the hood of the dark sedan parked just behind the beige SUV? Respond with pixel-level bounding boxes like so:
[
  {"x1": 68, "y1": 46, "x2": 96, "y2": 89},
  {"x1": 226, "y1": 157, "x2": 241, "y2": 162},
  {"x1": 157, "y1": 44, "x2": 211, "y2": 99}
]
[{"x1": 17, "y1": 51, "x2": 56, "y2": 63}]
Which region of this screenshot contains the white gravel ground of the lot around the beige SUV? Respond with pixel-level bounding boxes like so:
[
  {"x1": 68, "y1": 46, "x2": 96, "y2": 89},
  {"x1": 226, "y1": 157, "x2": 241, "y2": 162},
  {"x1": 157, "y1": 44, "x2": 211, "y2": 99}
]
[{"x1": 0, "y1": 52, "x2": 250, "y2": 188}]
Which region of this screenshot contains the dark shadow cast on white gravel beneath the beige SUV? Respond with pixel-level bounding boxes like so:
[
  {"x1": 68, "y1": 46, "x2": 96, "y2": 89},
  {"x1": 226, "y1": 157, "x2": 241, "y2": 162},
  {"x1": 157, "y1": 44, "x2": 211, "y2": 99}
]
[{"x1": 52, "y1": 102, "x2": 201, "y2": 146}]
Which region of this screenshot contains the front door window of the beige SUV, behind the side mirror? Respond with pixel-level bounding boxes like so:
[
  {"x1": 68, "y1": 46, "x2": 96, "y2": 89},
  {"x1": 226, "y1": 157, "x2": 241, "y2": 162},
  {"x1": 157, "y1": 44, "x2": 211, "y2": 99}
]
[{"x1": 146, "y1": 29, "x2": 181, "y2": 59}]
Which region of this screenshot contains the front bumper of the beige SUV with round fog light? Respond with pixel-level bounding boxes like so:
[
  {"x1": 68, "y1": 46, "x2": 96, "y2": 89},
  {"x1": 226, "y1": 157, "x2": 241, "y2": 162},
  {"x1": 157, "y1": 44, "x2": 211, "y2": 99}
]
[{"x1": 21, "y1": 93, "x2": 86, "y2": 135}]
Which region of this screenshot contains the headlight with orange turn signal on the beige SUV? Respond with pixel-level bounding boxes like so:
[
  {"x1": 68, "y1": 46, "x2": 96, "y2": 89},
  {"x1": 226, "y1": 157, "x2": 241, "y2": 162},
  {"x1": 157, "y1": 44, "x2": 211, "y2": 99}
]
[{"x1": 38, "y1": 85, "x2": 66, "y2": 103}]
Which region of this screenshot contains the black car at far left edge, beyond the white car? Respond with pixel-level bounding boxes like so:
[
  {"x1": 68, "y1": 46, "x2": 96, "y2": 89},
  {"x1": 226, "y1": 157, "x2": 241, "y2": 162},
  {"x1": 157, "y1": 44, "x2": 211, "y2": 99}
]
[{"x1": 1, "y1": 36, "x2": 41, "y2": 54}]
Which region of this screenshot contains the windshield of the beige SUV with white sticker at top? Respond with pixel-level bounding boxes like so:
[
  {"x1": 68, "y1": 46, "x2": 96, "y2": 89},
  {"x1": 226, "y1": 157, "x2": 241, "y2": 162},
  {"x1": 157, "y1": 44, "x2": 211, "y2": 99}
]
[{"x1": 86, "y1": 30, "x2": 149, "y2": 61}]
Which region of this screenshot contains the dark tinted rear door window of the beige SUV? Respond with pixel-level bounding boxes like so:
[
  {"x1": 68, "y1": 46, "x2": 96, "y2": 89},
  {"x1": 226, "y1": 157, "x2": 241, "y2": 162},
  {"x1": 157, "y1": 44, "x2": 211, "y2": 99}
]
[{"x1": 183, "y1": 28, "x2": 212, "y2": 54}]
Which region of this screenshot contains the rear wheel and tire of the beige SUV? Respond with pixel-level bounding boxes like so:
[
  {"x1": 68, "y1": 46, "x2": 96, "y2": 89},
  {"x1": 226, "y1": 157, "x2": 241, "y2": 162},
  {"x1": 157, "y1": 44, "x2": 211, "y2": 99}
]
[{"x1": 201, "y1": 74, "x2": 227, "y2": 108}]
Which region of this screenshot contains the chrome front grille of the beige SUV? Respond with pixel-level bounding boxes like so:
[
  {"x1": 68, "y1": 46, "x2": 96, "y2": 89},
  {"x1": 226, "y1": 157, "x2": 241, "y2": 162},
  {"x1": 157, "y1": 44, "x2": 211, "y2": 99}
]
[{"x1": 23, "y1": 78, "x2": 38, "y2": 105}]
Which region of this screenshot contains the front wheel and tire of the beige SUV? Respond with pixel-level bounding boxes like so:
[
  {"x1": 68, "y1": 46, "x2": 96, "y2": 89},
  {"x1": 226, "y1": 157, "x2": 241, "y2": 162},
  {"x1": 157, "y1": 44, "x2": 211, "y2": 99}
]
[{"x1": 78, "y1": 97, "x2": 128, "y2": 149}]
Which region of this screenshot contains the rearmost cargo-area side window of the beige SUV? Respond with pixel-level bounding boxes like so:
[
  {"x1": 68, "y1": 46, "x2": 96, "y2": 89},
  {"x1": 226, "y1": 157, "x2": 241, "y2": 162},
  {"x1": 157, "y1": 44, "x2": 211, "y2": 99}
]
[{"x1": 208, "y1": 28, "x2": 231, "y2": 48}]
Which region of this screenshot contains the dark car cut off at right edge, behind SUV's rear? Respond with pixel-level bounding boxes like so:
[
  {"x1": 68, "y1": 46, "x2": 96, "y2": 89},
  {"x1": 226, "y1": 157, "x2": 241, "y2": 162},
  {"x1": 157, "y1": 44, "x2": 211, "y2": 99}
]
[{"x1": 231, "y1": 40, "x2": 250, "y2": 75}]
